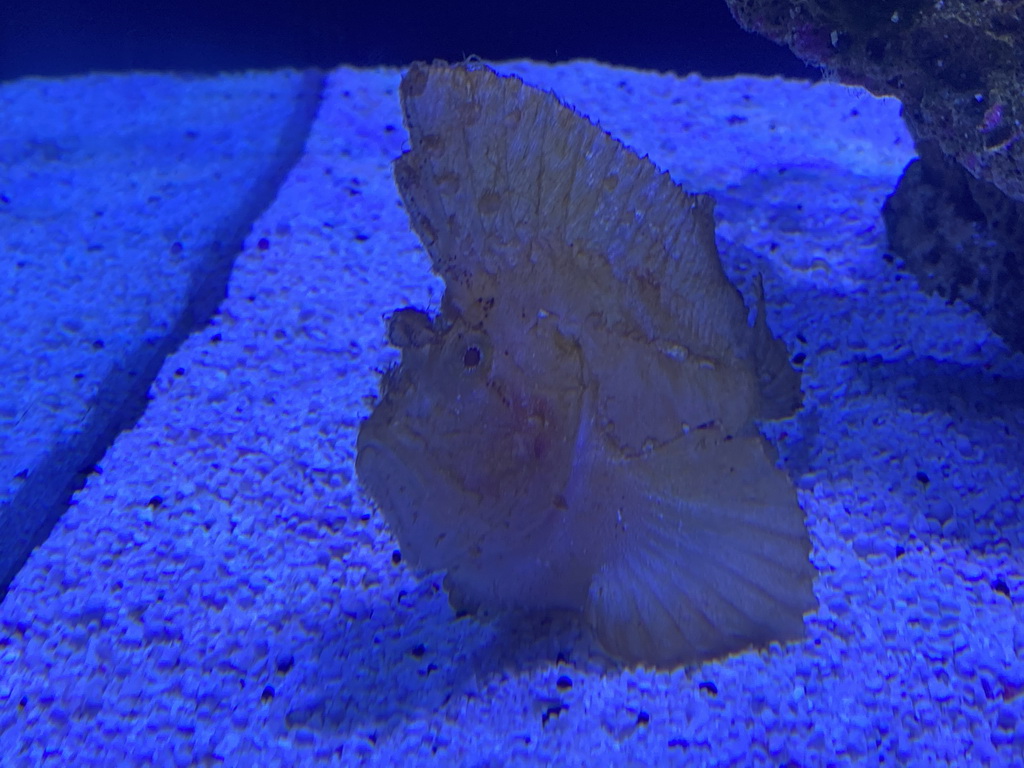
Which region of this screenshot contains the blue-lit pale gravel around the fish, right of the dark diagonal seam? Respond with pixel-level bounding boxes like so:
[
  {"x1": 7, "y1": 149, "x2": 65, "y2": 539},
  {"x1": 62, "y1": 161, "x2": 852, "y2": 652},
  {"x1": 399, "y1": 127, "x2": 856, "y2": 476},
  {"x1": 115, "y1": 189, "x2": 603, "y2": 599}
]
[{"x1": 0, "y1": 62, "x2": 1024, "y2": 768}]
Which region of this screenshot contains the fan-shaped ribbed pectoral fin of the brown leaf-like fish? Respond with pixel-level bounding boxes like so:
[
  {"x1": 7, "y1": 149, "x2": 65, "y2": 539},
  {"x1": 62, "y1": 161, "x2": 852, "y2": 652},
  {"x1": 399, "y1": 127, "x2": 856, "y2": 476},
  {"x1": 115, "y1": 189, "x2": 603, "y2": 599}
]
[{"x1": 584, "y1": 436, "x2": 817, "y2": 667}]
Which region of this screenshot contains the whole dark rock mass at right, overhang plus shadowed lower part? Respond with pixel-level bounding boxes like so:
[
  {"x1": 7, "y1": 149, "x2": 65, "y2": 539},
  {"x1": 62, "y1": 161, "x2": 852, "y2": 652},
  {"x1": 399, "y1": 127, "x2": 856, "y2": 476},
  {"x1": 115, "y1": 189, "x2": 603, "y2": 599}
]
[{"x1": 726, "y1": 0, "x2": 1024, "y2": 348}]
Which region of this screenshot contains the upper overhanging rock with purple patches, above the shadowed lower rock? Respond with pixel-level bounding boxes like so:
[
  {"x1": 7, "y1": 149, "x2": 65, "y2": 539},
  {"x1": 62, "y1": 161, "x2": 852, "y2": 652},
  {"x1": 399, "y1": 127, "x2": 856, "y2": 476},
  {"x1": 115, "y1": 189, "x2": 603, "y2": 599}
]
[{"x1": 726, "y1": 0, "x2": 1024, "y2": 201}]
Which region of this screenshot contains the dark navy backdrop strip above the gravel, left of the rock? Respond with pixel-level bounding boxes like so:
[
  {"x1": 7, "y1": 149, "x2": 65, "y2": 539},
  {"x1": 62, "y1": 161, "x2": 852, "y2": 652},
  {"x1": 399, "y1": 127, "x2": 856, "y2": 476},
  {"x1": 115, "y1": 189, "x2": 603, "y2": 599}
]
[{"x1": 0, "y1": 0, "x2": 817, "y2": 79}]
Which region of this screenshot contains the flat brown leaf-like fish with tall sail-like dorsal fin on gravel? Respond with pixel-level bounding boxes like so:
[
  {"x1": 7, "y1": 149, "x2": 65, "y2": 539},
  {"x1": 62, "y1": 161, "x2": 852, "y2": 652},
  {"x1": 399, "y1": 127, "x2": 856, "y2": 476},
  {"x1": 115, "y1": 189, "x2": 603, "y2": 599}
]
[{"x1": 355, "y1": 61, "x2": 817, "y2": 669}]
